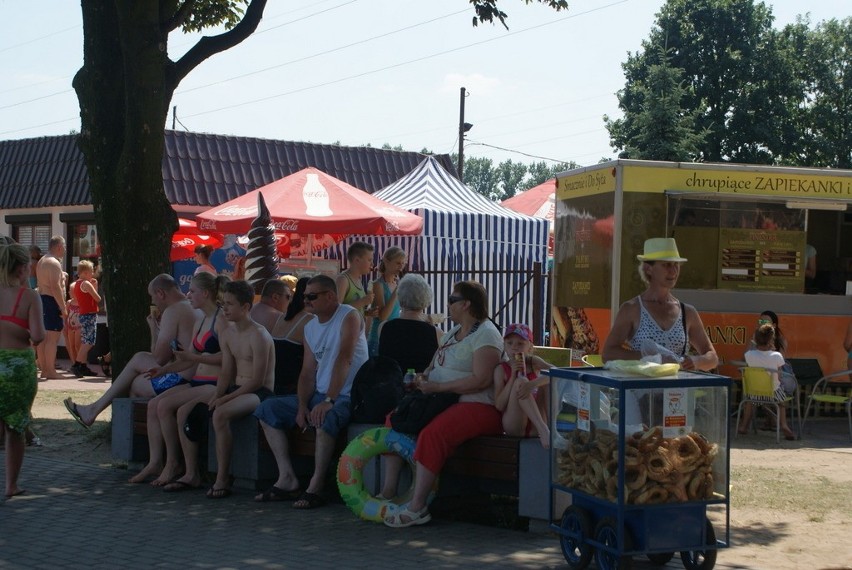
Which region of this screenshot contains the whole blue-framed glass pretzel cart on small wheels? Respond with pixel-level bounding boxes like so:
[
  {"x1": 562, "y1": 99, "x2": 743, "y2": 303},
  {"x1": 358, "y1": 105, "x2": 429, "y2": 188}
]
[{"x1": 550, "y1": 368, "x2": 731, "y2": 570}]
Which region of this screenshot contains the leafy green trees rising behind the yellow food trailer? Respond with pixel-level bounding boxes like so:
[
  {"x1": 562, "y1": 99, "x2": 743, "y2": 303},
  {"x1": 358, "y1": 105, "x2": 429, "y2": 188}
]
[{"x1": 605, "y1": 0, "x2": 852, "y2": 168}]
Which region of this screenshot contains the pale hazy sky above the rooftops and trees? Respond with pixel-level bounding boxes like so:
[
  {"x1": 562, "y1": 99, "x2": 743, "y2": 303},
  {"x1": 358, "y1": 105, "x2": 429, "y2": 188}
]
[{"x1": 0, "y1": 0, "x2": 849, "y2": 166}]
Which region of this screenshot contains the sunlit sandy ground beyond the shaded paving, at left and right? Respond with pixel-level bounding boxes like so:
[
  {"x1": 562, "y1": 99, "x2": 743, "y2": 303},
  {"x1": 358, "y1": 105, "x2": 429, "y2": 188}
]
[{"x1": 13, "y1": 364, "x2": 852, "y2": 570}]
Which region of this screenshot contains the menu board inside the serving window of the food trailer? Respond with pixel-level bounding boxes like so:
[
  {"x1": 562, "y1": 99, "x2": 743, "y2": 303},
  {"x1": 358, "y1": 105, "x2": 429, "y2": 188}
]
[{"x1": 717, "y1": 228, "x2": 805, "y2": 293}]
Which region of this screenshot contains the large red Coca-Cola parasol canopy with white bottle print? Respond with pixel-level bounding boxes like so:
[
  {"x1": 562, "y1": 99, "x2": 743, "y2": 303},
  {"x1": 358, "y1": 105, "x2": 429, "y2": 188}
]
[{"x1": 198, "y1": 167, "x2": 423, "y2": 235}]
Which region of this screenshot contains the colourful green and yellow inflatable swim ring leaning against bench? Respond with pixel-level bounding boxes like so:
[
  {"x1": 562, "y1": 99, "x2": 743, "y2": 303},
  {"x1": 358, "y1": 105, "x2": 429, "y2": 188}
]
[{"x1": 337, "y1": 427, "x2": 437, "y2": 522}]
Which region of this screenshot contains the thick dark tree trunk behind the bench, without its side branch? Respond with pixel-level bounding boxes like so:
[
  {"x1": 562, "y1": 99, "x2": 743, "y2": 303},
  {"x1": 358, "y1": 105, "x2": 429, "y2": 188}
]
[{"x1": 74, "y1": 0, "x2": 177, "y2": 371}]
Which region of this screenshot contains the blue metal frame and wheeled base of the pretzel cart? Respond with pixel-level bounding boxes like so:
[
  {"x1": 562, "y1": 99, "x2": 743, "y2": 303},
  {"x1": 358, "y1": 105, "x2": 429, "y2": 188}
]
[{"x1": 550, "y1": 368, "x2": 731, "y2": 570}]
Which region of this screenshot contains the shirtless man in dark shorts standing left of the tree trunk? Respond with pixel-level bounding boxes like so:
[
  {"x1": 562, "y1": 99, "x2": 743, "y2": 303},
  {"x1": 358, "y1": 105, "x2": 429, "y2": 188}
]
[{"x1": 36, "y1": 236, "x2": 67, "y2": 380}]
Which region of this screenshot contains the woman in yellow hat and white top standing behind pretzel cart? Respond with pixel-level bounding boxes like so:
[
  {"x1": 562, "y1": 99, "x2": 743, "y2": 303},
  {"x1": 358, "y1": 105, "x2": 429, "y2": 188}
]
[{"x1": 602, "y1": 238, "x2": 719, "y2": 370}]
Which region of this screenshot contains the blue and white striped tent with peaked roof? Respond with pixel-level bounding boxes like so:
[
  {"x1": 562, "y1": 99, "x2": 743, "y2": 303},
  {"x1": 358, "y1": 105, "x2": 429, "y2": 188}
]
[{"x1": 322, "y1": 153, "x2": 548, "y2": 341}]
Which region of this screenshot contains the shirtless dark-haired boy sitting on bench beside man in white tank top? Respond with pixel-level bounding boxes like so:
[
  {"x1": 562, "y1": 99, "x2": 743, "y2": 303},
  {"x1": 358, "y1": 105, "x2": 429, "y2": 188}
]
[{"x1": 204, "y1": 281, "x2": 275, "y2": 499}]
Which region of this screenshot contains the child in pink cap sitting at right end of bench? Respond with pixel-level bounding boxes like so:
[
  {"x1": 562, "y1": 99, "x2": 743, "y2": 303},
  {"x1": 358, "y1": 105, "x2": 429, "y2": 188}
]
[{"x1": 494, "y1": 323, "x2": 552, "y2": 449}]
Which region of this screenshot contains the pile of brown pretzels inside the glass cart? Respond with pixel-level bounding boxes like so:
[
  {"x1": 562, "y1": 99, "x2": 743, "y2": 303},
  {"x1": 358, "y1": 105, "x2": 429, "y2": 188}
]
[{"x1": 556, "y1": 426, "x2": 719, "y2": 505}]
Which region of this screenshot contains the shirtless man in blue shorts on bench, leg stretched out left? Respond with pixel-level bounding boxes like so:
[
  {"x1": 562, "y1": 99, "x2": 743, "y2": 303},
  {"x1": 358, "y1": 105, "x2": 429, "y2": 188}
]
[{"x1": 64, "y1": 273, "x2": 200, "y2": 428}]
